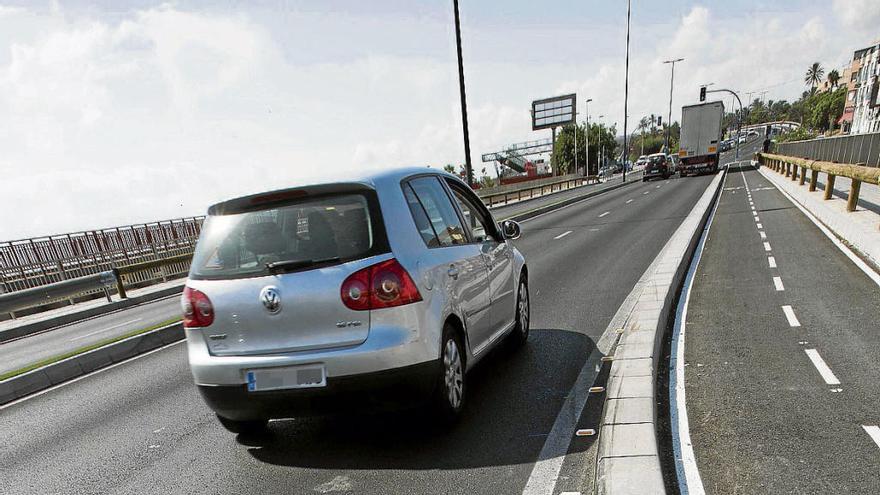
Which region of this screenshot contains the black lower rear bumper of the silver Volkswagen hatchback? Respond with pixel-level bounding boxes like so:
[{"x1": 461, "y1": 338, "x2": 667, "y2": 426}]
[{"x1": 198, "y1": 360, "x2": 440, "y2": 421}]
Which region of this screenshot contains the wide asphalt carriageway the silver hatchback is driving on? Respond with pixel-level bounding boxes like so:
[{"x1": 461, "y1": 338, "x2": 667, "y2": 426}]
[{"x1": 0, "y1": 170, "x2": 711, "y2": 494}]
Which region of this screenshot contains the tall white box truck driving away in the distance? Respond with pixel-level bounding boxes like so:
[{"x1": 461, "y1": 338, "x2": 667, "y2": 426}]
[{"x1": 678, "y1": 101, "x2": 724, "y2": 177}]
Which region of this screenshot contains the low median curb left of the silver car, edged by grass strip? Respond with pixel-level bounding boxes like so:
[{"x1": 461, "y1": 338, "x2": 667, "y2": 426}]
[{"x1": 0, "y1": 322, "x2": 184, "y2": 406}]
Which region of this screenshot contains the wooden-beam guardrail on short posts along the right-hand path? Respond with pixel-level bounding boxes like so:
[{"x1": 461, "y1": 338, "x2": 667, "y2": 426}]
[{"x1": 757, "y1": 153, "x2": 880, "y2": 221}]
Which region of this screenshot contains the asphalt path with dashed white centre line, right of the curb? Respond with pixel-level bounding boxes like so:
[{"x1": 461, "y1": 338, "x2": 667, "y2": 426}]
[{"x1": 685, "y1": 162, "x2": 880, "y2": 494}]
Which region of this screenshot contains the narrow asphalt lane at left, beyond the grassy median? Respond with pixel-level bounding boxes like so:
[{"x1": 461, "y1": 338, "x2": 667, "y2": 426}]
[{"x1": 0, "y1": 295, "x2": 180, "y2": 373}]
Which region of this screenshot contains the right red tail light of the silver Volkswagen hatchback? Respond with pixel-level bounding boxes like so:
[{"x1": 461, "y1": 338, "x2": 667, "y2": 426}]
[{"x1": 340, "y1": 258, "x2": 422, "y2": 311}]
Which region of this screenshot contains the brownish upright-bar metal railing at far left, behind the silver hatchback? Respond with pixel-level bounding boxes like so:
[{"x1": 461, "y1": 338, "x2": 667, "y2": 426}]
[{"x1": 0, "y1": 217, "x2": 204, "y2": 294}]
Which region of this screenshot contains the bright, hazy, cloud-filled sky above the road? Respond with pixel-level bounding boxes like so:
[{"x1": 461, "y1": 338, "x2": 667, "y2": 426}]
[{"x1": 0, "y1": 0, "x2": 880, "y2": 240}]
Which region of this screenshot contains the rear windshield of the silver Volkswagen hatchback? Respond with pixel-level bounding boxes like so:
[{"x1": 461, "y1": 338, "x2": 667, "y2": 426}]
[{"x1": 190, "y1": 193, "x2": 388, "y2": 279}]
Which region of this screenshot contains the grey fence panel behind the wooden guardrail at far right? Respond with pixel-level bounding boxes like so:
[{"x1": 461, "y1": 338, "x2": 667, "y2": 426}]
[{"x1": 776, "y1": 132, "x2": 880, "y2": 167}]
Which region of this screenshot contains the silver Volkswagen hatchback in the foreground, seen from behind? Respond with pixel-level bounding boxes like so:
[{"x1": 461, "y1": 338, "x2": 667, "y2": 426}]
[{"x1": 182, "y1": 168, "x2": 529, "y2": 432}]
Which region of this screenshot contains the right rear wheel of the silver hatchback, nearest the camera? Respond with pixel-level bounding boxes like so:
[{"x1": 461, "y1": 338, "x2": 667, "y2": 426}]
[{"x1": 431, "y1": 323, "x2": 467, "y2": 423}]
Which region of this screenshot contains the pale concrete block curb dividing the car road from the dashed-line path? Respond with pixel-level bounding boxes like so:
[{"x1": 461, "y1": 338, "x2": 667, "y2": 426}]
[{"x1": 596, "y1": 167, "x2": 727, "y2": 495}]
